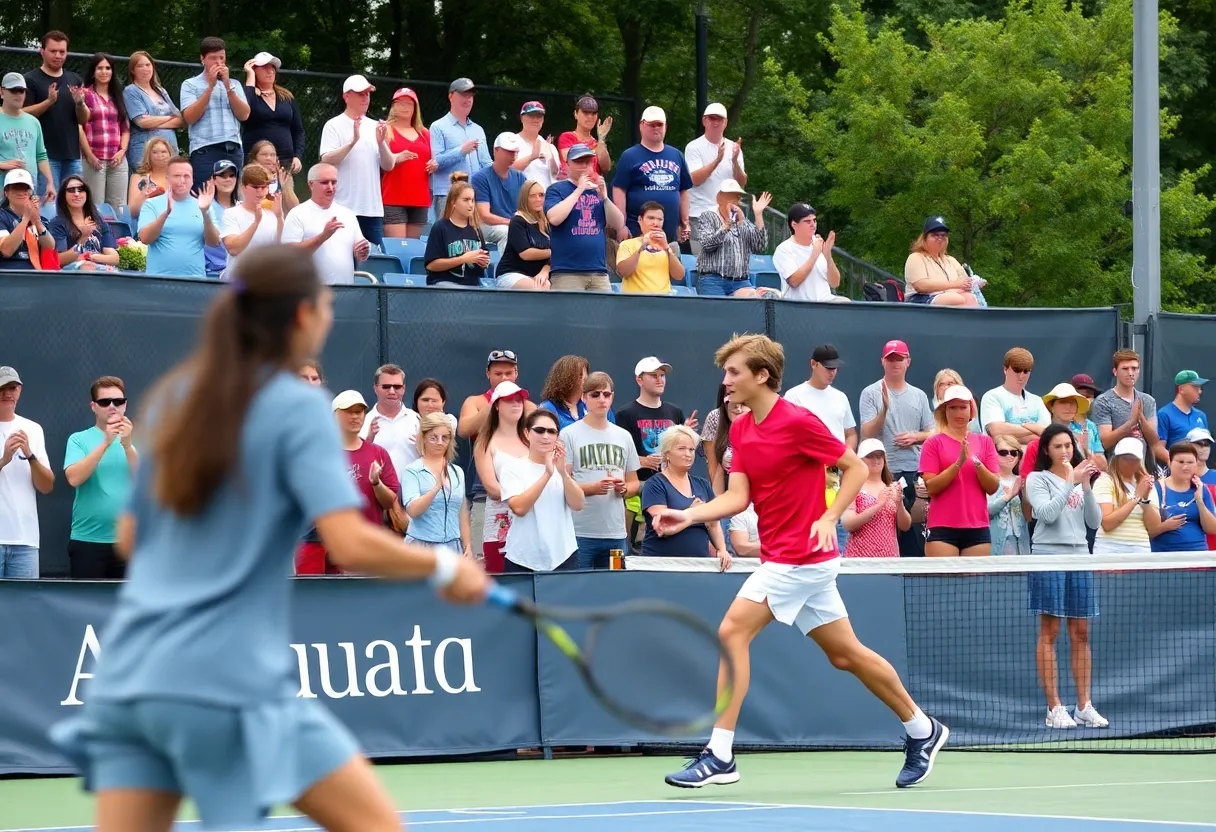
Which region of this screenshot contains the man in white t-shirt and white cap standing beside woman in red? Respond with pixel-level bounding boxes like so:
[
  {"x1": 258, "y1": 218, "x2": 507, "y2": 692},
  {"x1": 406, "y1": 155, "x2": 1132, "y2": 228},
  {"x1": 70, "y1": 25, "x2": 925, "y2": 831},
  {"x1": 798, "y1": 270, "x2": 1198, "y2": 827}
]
[{"x1": 320, "y1": 75, "x2": 394, "y2": 246}]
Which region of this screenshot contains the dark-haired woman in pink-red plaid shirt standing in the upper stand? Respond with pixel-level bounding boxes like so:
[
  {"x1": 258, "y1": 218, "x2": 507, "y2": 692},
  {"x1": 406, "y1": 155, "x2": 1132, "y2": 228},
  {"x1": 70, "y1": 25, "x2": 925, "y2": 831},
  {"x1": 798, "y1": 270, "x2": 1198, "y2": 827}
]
[{"x1": 78, "y1": 52, "x2": 131, "y2": 212}]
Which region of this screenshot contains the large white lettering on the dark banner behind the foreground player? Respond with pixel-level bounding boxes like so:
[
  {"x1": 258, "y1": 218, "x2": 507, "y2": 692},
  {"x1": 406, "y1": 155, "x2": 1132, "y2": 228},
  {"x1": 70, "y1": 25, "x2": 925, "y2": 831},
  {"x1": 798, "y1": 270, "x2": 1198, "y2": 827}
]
[{"x1": 60, "y1": 624, "x2": 482, "y2": 705}]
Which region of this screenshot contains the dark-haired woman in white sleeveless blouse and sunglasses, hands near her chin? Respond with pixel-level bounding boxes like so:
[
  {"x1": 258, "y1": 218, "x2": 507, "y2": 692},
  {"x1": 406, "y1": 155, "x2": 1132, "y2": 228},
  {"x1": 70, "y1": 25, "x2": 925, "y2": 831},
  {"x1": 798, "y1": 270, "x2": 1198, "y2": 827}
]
[{"x1": 499, "y1": 407, "x2": 585, "y2": 573}]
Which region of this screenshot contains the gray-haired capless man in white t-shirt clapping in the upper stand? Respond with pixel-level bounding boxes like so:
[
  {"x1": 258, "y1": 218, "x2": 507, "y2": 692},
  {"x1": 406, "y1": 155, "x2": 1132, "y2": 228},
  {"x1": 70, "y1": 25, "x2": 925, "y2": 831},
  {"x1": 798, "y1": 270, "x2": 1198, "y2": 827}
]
[{"x1": 282, "y1": 162, "x2": 371, "y2": 286}]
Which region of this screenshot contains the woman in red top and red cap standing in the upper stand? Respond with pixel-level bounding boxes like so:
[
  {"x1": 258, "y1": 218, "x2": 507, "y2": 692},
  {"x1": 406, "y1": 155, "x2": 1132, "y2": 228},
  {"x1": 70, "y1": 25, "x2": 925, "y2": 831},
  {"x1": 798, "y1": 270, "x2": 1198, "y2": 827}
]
[{"x1": 381, "y1": 86, "x2": 439, "y2": 237}]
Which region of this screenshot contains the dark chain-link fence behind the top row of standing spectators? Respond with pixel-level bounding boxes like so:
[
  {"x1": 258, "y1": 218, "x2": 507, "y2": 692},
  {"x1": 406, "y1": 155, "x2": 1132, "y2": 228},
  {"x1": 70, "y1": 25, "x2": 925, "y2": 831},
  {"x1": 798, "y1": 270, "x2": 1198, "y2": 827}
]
[{"x1": 0, "y1": 46, "x2": 640, "y2": 172}]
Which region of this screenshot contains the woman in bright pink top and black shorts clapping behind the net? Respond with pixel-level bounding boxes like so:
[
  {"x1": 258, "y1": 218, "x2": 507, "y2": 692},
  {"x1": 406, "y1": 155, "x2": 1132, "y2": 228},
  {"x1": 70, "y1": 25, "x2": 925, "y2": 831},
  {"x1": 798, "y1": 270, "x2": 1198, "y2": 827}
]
[{"x1": 921, "y1": 384, "x2": 1001, "y2": 557}]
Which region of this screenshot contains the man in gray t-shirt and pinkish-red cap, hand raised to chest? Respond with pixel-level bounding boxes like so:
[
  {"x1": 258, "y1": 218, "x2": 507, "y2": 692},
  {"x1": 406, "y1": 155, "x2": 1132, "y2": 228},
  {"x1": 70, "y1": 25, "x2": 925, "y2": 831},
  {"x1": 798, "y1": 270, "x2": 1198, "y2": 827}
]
[{"x1": 857, "y1": 341, "x2": 934, "y2": 557}]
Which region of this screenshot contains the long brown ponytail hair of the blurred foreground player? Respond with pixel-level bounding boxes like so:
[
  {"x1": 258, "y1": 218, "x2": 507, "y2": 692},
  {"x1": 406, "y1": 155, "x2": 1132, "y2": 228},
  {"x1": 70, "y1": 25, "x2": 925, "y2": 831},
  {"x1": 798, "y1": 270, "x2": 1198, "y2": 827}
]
[{"x1": 151, "y1": 246, "x2": 322, "y2": 516}]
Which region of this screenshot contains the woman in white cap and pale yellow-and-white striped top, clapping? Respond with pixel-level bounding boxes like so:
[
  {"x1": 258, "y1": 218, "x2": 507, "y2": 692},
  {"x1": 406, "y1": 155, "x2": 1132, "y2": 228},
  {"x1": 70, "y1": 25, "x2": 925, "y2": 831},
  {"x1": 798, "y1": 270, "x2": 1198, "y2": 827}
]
[{"x1": 1093, "y1": 437, "x2": 1161, "y2": 555}]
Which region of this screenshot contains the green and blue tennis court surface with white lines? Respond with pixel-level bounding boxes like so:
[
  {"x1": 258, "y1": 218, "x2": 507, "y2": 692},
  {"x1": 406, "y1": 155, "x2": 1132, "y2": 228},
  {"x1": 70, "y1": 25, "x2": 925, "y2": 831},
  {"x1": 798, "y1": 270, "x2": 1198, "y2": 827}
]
[{"x1": 0, "y1": 752, "x2": 1216, "y2": 832}]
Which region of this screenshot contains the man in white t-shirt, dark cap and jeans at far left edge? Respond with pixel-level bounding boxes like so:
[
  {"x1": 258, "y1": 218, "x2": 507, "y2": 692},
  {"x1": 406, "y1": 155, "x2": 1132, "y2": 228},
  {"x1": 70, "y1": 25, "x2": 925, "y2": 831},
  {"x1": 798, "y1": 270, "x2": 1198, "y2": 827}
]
[{"x1": 0, "y1": 367, "x2": 55, "y2": 578}]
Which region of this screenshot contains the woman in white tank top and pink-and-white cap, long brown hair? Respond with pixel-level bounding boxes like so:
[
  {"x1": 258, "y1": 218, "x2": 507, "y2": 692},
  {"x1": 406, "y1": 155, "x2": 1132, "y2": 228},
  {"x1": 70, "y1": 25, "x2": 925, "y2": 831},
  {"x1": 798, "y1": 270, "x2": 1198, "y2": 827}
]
[{"x1": 473, "y1": 381, "x2": 528, "y2": 574}]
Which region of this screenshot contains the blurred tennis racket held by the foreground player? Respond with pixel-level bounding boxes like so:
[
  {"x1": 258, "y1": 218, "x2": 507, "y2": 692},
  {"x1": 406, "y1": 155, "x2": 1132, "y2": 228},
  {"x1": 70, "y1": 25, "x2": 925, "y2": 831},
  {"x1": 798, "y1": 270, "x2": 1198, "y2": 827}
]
[{"x1": 486, "y1": 584, "x2": 734, "y2": 736}]
